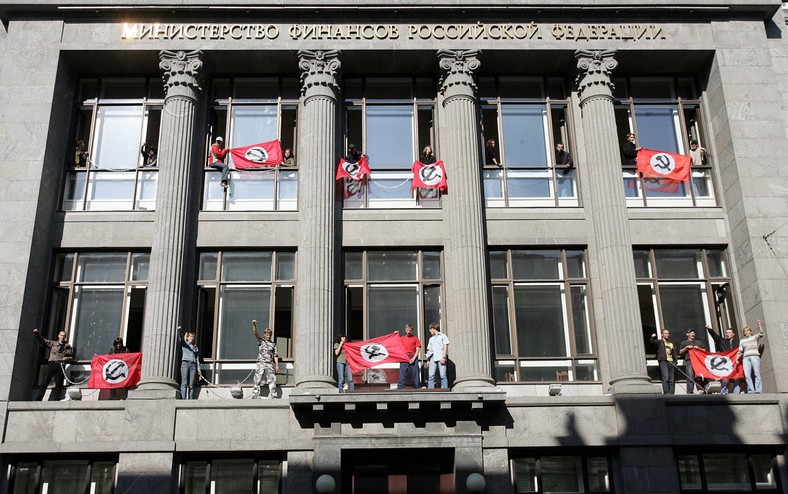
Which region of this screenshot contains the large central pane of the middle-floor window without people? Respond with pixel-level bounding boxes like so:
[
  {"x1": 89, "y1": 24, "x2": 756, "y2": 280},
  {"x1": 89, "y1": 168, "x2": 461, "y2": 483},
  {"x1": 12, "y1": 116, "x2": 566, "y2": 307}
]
[{"x1": 514, "y1": 285, "x2": 567, "y2": 357}]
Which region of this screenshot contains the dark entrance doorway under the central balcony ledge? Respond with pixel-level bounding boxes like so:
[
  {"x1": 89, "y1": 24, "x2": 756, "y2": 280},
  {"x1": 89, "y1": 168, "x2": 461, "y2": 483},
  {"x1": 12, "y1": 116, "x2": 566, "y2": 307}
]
[{"x1": 342, "y1": 447, "x2": 454, "y2": 494}]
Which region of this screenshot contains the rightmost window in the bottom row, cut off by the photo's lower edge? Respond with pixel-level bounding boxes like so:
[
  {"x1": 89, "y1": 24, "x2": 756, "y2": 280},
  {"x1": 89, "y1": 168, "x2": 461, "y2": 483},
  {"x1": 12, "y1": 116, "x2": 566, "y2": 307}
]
[{"x1": 676, "y1": 452, "x2": 782, "y2": 493}]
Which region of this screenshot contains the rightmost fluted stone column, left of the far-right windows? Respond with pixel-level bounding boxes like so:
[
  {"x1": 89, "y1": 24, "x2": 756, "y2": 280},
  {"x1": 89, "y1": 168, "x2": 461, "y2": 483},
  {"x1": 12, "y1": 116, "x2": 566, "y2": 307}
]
[{"x1": 575, "y1": 50, "x2": 658, "y2": 393}]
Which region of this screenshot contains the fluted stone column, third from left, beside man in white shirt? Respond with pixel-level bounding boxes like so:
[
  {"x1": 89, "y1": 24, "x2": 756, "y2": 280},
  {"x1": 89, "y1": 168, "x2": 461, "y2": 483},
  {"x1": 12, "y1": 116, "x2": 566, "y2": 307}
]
[{"x1": 438, "y1": 50, "x2": 494, "y2": 390}]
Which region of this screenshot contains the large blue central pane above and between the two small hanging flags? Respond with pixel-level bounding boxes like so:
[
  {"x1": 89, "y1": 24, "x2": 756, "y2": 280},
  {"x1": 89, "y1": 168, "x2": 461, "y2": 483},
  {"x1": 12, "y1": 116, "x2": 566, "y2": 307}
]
[{"x1": 366, "y1": 106, "x2": 415, "y2": 169}]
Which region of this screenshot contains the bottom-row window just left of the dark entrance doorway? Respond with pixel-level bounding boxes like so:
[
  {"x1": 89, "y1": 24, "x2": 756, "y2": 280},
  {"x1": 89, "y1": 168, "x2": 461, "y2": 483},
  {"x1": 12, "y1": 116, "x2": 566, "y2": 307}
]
[{"x1": 178, "y1": 458, "x2": 282, "y2": 494}]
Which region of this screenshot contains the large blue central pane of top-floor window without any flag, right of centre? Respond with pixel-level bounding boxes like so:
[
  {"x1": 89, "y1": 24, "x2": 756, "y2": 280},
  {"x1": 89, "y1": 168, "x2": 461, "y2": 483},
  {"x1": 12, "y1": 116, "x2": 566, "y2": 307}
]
[{"x1": 501, "y1": 105, "x2": 548, "y2": 167}]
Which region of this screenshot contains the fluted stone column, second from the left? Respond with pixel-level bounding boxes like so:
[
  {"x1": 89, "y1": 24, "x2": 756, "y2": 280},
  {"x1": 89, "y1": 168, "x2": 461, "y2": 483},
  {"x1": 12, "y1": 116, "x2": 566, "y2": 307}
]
[{"x1": 295, "y1": 50, "x2": 342, "y2": 388}]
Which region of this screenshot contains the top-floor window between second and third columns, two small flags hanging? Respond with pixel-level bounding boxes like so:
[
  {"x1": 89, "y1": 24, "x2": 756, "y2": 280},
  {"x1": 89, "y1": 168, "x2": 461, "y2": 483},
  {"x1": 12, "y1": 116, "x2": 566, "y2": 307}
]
[{"x1": 343, "y1": 77, "x2": 440, "y2": 208}]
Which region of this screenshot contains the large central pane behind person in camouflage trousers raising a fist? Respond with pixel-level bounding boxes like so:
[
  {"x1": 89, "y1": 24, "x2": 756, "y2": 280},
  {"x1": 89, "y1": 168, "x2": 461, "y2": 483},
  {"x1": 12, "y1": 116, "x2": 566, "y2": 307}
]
[{"x1": 218, "y1": 286, "x2": 271, "y2": 359}]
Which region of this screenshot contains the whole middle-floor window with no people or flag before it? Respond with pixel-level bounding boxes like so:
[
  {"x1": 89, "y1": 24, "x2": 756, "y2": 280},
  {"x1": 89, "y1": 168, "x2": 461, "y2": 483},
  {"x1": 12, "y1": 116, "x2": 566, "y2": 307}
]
[{"x1": 490, "y1": 249, "x2": 599, "y2": 382}]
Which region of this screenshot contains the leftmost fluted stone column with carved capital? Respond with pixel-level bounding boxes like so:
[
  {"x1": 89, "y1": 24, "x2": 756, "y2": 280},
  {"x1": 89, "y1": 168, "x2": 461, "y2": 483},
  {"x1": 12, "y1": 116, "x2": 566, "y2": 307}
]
[{"x1": 132, "y1": 50, "x2": 203, "y2": 398}]
